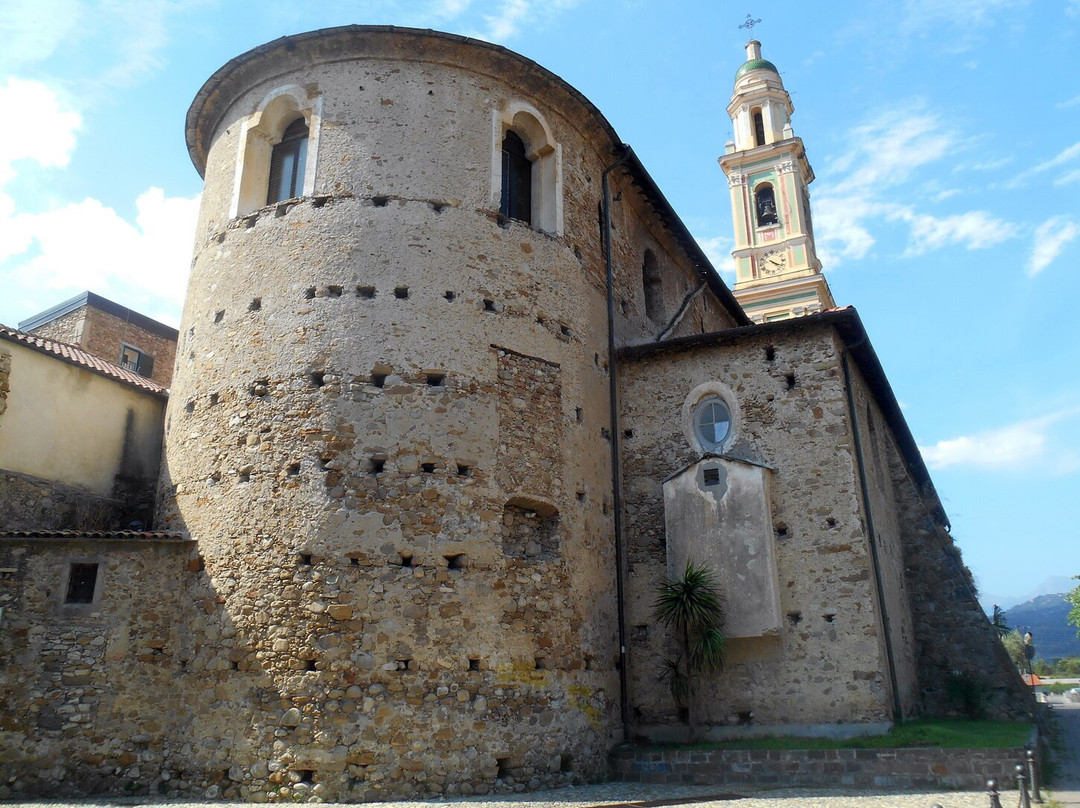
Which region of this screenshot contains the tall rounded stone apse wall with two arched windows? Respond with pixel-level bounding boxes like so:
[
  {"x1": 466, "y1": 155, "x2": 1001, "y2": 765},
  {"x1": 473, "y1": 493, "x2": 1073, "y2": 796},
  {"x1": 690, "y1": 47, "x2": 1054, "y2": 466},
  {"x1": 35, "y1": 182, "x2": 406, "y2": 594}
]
[{"x1": 162, "y1": 26, "x2": 619, "y2": 799}]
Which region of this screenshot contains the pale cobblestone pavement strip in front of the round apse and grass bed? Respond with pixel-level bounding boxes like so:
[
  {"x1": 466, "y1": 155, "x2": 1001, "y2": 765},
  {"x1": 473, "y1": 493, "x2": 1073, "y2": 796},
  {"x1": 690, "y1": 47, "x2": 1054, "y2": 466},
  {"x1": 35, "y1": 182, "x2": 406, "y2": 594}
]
[{"x1": 0, "y1": 783, "x2": 993, "y2": 808}]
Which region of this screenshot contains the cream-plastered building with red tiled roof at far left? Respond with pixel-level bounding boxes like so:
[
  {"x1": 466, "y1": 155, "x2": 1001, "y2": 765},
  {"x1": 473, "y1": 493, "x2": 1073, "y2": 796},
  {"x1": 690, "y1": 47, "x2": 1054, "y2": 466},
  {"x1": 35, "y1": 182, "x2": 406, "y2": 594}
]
[{"x1": 0, "y1": 326, "x2": 166, "y2": 530}]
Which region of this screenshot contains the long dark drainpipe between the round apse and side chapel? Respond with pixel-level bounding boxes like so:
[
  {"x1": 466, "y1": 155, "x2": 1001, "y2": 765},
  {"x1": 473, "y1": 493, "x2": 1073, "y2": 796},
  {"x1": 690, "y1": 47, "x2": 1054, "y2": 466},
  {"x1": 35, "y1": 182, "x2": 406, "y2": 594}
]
[{"x1": 600, "y1": 144, "x2": 634, "y2": 740}]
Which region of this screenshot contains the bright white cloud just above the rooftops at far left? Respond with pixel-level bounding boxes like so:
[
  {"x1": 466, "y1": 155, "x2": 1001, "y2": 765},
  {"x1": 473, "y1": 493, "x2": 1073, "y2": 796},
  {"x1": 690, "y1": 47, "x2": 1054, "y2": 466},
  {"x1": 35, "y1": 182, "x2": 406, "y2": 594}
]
[{"x1": 0, "y1": 188, "x2": 199, "y2": 322}]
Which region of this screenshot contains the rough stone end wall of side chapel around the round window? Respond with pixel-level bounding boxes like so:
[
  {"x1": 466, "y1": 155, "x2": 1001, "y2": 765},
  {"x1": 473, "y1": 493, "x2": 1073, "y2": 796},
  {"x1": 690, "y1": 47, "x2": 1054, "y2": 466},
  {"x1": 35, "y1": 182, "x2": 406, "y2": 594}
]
[{"x1": 620, "y1": 323, "x2": 892, "y2": 737}]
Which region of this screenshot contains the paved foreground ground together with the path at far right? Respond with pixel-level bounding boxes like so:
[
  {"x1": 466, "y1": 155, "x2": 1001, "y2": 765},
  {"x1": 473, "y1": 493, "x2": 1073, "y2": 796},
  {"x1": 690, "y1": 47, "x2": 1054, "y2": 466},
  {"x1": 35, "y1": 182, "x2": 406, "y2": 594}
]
[{"x1": 8, "y1": 697, "x2": 1080, "y2": 808}]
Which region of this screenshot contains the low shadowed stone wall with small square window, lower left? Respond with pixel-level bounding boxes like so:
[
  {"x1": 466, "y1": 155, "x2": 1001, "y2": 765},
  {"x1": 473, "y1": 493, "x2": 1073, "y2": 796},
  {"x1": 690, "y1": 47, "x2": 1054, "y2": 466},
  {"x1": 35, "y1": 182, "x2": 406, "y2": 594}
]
[{"x1": 0, "y1": 534, "x2": 196, "y2": 799}]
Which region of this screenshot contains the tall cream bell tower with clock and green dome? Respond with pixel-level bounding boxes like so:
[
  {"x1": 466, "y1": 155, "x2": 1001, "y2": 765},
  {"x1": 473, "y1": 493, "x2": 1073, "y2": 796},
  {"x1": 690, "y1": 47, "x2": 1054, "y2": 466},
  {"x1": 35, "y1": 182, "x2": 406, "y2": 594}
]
[{"x1": 718, "y1": 40, "x2": 835, "y2": 323}]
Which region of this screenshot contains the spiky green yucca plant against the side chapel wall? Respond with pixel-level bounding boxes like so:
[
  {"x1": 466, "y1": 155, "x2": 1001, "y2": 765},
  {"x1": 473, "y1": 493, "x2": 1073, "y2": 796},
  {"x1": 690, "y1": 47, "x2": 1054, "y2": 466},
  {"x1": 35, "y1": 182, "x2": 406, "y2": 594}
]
[{"x1": 652, "y1": 560, "x2": 724, "y2": 742}]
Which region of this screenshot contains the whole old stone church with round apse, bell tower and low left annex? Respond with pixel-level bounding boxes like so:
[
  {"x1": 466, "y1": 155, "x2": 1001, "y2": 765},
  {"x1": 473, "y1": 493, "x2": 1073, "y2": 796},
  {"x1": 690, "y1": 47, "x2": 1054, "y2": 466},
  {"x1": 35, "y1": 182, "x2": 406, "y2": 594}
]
[{"x1": 0, "y1": 26, "x2": 1027, "y2": 800}]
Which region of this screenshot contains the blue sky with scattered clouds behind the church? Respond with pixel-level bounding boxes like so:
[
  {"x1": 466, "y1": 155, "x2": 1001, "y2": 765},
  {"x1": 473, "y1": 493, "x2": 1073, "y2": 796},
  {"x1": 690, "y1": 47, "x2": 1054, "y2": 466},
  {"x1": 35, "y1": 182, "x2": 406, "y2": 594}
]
[{"x1": 0, "y1": 0, "x2": 1080, "y2": 602}]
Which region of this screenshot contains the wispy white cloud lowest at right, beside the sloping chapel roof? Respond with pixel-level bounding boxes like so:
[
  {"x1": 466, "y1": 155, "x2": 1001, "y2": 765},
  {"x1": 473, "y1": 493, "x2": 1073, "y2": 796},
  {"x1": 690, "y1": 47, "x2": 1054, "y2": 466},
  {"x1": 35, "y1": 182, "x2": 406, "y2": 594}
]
[{"x1": 920, "y1": 408, "x2": 1080, "y2": 474}]
